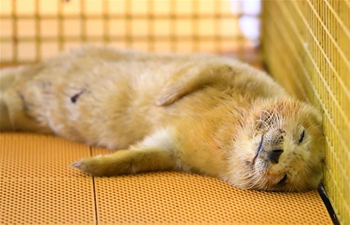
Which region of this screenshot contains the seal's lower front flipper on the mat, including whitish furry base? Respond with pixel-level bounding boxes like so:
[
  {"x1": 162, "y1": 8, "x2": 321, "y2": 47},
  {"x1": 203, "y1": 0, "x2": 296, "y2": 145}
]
[{"x1": 72, "y1": 128, "x2": 178, "y2": 176}]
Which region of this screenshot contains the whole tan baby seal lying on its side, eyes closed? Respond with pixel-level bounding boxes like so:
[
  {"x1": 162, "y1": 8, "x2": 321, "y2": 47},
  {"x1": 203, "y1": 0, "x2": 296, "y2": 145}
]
[{"x1": 0, "y1": 47, "x2": 325, "y2": 191}]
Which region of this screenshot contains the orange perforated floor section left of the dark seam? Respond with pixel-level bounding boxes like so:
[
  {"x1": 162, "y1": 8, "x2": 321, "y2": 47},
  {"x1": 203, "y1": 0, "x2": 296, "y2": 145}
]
[{"x1": 0, "y1": 133, "x2": 96, "y2": 224}]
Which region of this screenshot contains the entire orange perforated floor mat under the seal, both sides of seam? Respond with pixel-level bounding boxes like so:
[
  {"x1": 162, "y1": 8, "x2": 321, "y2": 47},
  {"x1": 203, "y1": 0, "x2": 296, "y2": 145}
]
[{"x1": 0, "y1": 133, "x2": 332, "y2": 224}]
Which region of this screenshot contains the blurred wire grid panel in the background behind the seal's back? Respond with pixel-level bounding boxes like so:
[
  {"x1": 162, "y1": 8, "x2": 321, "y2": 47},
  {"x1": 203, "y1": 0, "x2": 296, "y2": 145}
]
[{"x1": 0, "y1": 0, "x2": 249, "y2": 64}]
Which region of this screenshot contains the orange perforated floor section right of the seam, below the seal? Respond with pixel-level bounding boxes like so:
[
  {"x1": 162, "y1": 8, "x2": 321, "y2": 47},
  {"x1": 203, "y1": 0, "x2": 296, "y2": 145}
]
[{"x1": 93, "y1": 149, "x2": 332, "y2": 224}]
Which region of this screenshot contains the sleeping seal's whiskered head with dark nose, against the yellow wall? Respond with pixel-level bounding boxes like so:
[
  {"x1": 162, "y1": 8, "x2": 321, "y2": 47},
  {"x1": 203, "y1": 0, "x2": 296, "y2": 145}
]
[{"x1": 232, "y1": 98, "x2": 325, "y2": 191}]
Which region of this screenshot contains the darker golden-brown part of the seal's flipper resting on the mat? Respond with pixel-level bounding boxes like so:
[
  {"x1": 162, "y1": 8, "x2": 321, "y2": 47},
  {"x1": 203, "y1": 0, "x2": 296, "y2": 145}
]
[{"x1": 72, "y1": 147, "x2": 176, "y2": 176}]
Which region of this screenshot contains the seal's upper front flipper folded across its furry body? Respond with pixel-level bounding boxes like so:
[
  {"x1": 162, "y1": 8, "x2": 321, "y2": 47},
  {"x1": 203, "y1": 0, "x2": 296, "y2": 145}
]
[{"x1": 156, "y1": 62, "x2": 234, "y2": 106}]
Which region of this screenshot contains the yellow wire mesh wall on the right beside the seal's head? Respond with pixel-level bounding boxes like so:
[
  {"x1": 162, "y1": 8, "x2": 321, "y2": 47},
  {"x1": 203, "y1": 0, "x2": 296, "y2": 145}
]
[{"x1": 262, "y1": 0, "x2": 350, "y2": 224}]
